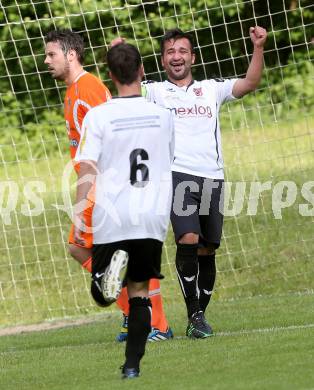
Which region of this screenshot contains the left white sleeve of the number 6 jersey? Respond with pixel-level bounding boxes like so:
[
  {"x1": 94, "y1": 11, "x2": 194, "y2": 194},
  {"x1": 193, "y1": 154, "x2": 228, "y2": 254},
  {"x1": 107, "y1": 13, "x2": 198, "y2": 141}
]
[{"x1": 74, "y1": 109, "x2": 103, "y2": 162}]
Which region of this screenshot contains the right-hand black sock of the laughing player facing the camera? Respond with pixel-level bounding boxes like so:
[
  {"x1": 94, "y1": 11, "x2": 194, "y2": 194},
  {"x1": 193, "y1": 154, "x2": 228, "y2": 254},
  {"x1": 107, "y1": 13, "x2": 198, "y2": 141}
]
[{"x1": 198, "y1": 254, "x2": 216, "y2": 312}]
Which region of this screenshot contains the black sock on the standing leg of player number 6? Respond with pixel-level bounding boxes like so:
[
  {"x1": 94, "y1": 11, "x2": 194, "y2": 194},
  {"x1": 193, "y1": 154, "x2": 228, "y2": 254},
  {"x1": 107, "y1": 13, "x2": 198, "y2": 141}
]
[{"x1": 125, "y1": 297, "x2": 152, "y2": 370}]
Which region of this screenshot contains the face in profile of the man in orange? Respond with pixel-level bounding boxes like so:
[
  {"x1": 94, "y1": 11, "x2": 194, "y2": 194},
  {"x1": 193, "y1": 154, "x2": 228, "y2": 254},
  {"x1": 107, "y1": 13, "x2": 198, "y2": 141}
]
[{"x1": 44, "y1": 42, "x2": 70, "y2": 81}]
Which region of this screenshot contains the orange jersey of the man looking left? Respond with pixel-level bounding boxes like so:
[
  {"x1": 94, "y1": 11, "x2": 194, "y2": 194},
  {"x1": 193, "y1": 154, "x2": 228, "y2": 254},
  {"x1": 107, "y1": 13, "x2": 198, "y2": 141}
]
[{"x1": 64, "y1": 72, "x2": 111, "y2": 163}]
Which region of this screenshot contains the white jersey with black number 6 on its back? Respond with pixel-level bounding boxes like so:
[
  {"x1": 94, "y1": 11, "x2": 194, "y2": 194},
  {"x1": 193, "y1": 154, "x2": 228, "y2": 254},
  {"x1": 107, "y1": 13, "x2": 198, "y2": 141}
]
[{"x1": 75, "y1": 96, "x2": 174, "y2": 244}]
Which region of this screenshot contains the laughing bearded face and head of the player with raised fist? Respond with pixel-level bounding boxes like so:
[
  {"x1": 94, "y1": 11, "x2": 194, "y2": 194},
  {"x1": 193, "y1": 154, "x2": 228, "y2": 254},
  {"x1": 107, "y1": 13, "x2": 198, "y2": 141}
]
[{"x1": 161, "y1": 38, "x2": 195, "y2": 85}]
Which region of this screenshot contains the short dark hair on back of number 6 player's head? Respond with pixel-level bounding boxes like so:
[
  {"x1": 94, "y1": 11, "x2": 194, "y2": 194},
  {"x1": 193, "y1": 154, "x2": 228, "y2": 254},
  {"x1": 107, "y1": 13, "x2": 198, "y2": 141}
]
[{"x1": 107, "y1": 43, "x2": 142, "y2": 85}]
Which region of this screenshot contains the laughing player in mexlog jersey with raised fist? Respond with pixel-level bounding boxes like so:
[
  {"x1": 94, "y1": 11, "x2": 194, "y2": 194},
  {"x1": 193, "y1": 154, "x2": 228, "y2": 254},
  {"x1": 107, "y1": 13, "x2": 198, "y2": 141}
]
[{"x1": 140, "y1": 26, "x2": 267, "y2": 338}]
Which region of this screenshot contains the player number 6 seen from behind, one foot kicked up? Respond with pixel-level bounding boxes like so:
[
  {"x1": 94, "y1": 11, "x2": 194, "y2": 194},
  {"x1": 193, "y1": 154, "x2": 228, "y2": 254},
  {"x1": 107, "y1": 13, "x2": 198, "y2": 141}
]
[{"x1": 74, "y1": 44, "x2": 174, "y2": 378}]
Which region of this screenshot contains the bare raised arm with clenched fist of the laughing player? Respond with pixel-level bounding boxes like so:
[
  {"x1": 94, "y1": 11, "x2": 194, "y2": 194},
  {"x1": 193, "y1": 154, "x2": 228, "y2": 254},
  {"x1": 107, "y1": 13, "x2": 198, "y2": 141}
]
[{"x1": 232, "y1": 26, "x2": 267, "y2": 98}]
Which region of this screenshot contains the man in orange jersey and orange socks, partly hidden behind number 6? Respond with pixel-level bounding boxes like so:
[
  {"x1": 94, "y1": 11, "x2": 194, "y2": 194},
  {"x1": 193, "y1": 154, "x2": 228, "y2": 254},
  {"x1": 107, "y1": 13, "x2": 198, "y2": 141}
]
[{"x1": 45, "y1": 29, "x2": 173, "y2": 341}]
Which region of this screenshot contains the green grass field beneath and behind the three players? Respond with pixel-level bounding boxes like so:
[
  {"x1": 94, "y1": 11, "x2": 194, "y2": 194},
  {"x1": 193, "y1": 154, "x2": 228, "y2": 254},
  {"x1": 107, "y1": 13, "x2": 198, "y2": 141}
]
[{"x1": 0, "y1": 115, "x2": 314, "y2": 390}]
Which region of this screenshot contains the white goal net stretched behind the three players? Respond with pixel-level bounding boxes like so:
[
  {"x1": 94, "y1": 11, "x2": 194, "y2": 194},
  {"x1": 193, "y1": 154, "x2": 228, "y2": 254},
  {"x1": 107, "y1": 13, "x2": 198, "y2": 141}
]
[{"x1": 0, "y1": 0, "x2": 314, "y2": 326}]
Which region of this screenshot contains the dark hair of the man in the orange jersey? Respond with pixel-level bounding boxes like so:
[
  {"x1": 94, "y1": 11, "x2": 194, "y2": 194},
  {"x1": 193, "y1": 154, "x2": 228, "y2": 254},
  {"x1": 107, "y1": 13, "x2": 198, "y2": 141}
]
[{"x1": 45, "y1": 29, "x2": 84, "y2": 64}]
